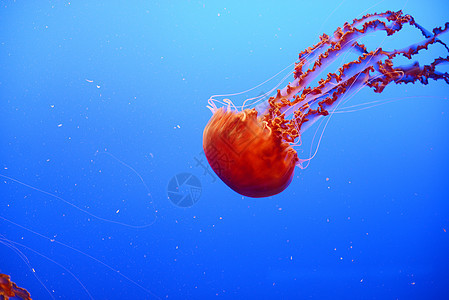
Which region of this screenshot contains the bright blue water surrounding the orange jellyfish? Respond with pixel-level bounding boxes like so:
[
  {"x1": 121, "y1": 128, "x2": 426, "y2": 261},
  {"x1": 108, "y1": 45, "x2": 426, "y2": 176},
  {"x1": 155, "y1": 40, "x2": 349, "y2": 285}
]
[{"x1": 0, "y1": 0, "x2": 449, "y2": 299}]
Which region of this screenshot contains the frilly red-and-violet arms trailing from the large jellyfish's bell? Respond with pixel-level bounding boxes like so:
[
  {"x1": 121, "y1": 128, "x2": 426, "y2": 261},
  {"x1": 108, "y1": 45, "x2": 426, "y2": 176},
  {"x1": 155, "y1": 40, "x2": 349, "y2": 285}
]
[{"x1": 261, "y1": 11, "x2": 449, "y2": 143}]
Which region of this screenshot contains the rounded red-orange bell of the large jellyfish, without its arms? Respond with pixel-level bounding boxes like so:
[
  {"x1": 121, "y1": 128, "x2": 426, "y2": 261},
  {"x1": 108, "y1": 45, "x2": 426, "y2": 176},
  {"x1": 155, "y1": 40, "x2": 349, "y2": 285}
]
[{"x1": 203, "y1": 108, "x2": 298, "y2": 198}]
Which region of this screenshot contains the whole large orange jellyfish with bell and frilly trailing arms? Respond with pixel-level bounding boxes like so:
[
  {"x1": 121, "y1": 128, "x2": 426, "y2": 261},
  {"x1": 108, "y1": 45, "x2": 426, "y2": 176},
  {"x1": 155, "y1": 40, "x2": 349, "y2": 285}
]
[{"x1": 203, "y1": 11, "x2": 449, "y2": 198}]
